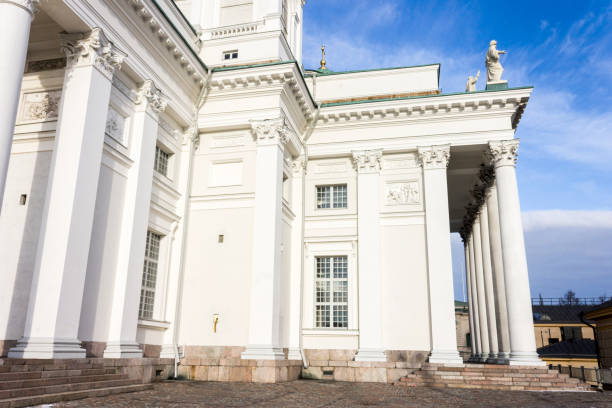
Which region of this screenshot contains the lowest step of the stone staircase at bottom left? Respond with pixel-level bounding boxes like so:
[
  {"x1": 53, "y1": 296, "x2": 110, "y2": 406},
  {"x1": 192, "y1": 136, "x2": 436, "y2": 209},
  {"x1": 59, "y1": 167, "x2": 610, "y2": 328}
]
[{"x1": 0, "y1": 384, "x2": 153, "y2": 408}]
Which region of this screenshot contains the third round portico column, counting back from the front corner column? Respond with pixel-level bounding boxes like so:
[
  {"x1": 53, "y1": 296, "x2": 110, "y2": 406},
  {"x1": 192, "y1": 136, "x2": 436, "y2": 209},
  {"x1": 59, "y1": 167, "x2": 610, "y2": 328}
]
[{"x1": 480, "y1": 202, "x2": 499, "y2": 364}]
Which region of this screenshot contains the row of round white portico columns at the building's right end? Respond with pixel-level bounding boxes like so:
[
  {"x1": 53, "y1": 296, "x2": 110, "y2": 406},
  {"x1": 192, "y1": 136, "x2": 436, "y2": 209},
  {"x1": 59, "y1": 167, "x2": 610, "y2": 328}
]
[{"x1": 461, "y1": 139, "x2": 545, "y2": 365}]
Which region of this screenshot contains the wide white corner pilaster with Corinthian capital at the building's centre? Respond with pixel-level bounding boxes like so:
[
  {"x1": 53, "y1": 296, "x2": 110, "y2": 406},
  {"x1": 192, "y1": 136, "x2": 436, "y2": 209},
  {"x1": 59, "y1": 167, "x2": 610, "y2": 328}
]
[{"x1": 241, "y1": 119, "x2": 289, "y2": 360}]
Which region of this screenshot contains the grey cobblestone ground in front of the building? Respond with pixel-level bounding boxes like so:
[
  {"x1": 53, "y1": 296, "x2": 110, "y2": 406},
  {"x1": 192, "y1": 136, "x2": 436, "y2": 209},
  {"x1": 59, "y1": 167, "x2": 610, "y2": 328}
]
[{"x1": 47, "y1": 380, "x2": 612, "y2": 408}]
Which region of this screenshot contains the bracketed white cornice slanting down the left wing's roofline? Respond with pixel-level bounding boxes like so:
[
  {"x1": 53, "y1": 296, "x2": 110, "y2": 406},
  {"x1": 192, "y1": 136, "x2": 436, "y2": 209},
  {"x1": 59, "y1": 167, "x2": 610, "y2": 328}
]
[{"x1": 128, "y1": 0, "x2": 205, "y2": 86}]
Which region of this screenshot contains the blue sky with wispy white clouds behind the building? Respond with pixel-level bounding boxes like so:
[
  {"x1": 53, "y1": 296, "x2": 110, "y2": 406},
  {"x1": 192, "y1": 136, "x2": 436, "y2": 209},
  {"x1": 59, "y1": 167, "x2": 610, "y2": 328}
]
[{"x1": 304, "y1": 0, "x2": 612, "y2": 299}]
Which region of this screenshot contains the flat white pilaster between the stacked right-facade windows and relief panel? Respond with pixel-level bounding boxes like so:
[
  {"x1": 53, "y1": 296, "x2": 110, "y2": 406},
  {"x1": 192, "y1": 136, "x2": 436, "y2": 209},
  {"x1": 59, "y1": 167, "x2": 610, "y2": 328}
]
[{"x1": 353, "y1": 149, "x2": 387, "y2": 361}]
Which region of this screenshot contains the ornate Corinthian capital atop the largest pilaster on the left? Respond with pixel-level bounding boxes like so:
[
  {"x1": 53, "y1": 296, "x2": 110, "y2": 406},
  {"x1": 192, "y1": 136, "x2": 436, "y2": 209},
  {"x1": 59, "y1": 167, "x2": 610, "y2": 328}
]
[{"x1": 61, "y1": 28, "x2": 126, "y2": 79}]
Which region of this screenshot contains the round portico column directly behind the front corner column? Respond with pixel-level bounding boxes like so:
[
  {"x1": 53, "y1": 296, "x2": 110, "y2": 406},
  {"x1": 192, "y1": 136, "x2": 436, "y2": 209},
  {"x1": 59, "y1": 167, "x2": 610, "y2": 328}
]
[{"x1": 486, "y1": 181, "x2": 510, "y2": 363}]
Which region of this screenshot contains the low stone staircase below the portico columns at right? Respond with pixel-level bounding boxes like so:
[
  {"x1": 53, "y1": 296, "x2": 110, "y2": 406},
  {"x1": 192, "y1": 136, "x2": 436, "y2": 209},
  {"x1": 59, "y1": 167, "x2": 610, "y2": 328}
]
[{"x1": 395, "y1": 363, "x2": 591, "y2": 391}]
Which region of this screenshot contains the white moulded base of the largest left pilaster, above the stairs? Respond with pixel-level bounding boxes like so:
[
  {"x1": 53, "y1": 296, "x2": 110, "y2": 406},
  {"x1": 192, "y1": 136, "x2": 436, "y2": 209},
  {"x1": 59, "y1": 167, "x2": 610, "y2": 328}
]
[{"x1": 8, "y1": 337, "x2": 86, "y2": 359}]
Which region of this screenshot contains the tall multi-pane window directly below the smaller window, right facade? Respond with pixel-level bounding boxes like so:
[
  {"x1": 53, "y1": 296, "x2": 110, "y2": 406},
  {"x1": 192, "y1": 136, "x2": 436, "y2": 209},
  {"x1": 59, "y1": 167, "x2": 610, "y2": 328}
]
[{"x1": 315, "y1": 256, "x2": 348, "y2": 328}]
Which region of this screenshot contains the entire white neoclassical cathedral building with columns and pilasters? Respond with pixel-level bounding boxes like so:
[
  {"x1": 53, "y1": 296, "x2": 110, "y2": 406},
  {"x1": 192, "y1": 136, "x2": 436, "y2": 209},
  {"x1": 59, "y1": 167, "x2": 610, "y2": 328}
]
[{"x1": 0, "y1": 0, "x2": 542, "y2": 380}]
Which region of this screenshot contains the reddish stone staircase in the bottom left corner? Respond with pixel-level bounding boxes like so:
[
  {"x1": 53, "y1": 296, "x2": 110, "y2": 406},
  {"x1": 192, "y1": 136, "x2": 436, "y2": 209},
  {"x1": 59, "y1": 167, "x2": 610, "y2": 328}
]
[{"x1": 0, "y1": 359, "x2": 153, "y2": 408}]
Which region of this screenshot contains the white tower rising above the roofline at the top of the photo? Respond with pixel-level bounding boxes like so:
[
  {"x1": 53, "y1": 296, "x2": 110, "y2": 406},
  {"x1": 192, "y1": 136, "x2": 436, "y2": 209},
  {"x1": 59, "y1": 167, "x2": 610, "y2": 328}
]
[{"x1": 176, "y1": 0, "x2": 306, "y2": 66}]
